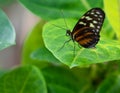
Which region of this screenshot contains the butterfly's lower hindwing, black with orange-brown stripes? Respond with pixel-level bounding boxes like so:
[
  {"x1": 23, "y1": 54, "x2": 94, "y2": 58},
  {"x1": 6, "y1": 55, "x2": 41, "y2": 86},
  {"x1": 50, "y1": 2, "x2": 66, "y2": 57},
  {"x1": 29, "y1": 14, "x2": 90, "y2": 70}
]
[{"x1": 74, "y1": 27, "x2": 100, "y2": 48}]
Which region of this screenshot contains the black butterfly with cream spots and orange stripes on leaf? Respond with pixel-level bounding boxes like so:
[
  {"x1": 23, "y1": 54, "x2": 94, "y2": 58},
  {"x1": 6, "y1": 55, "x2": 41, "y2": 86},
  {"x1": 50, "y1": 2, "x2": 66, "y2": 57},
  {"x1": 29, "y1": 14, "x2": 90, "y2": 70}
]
[{"x1": 66, "y1": 8, "x2": 105, "y2": 48}]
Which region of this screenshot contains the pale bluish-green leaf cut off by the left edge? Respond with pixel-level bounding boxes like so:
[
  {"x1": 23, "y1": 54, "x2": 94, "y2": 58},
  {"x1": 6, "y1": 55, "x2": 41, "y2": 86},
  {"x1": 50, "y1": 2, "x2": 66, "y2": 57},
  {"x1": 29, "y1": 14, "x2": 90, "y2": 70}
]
[{"x1": 0, "y1": 9, "x2": 15, "y2": 50}]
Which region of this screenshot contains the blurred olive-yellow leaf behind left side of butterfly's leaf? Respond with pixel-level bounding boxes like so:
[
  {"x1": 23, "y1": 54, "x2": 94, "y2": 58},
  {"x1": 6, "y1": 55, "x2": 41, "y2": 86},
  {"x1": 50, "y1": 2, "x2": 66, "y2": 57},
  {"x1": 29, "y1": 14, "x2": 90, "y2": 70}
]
[{"x1": 22, "y1": 20, "x2": 45, "y2": 64}]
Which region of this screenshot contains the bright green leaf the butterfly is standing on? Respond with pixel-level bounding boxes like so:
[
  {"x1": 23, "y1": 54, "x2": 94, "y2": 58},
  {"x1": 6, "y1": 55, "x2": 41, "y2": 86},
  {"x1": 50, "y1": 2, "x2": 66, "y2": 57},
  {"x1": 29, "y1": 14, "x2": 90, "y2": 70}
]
[{"x1": 43, "y1": 19, "x2": 120, "y2": 67}]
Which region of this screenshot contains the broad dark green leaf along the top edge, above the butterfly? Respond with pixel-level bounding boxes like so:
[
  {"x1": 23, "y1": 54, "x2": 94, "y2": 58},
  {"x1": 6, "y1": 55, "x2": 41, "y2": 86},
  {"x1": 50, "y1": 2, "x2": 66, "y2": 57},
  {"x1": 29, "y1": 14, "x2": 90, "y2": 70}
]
[{"x1": 19, "y1": 0, "x2": 103, "y2": 20}]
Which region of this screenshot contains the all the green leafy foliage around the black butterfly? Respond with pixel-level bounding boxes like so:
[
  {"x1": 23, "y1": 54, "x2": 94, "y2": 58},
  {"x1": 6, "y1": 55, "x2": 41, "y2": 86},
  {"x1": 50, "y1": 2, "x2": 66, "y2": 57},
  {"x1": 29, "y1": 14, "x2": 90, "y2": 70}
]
[{"x1": 0, "y1": 0, "x2": 120, "y2": 93}]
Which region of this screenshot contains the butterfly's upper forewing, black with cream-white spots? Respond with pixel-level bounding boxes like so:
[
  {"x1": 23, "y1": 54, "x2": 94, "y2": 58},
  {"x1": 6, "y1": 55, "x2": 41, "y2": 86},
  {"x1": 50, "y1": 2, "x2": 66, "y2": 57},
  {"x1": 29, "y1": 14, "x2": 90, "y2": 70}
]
[{"x1": 72, "y1": 8, "x2": 105, "y2": 33}]
